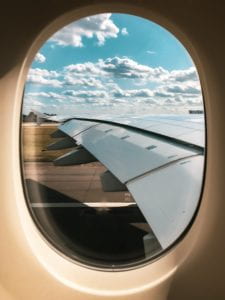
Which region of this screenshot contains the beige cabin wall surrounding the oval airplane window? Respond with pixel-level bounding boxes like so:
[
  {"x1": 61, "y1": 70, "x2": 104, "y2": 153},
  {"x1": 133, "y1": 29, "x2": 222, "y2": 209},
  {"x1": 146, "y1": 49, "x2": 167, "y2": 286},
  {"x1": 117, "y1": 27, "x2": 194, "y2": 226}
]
[{"x1": 0, "y1": 0, "x2": 225, "y2": 300}]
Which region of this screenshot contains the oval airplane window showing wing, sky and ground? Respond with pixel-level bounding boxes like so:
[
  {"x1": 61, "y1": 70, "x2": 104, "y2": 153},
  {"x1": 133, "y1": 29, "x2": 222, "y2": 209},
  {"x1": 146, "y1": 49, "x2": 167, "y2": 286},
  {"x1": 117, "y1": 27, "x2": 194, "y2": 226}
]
[{"x1": 21, "y1": 13, "x2": 205, "y2": 270}]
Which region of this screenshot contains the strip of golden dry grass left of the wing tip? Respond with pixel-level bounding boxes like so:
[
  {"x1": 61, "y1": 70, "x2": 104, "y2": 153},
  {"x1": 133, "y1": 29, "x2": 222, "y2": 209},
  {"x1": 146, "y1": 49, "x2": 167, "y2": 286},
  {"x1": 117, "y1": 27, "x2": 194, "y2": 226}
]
[{"x1": 22, "y1": 123, "x2": 68, "y2": 162}]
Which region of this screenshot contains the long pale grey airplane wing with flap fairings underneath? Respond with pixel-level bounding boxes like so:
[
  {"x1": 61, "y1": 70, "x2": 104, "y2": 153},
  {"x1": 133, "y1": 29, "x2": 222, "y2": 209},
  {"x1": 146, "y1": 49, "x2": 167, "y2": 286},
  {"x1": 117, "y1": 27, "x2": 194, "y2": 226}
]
[{"x1": 44, "y1": 118, "x2": 204, "y2": 249}]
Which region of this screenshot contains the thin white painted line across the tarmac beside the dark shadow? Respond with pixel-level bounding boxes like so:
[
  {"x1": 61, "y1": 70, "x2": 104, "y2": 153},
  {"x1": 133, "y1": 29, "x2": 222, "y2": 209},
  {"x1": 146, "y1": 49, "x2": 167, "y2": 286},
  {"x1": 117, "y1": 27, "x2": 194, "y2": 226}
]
[{"x1": 30, "y1": 202, "x2": 136, "y2": 208}]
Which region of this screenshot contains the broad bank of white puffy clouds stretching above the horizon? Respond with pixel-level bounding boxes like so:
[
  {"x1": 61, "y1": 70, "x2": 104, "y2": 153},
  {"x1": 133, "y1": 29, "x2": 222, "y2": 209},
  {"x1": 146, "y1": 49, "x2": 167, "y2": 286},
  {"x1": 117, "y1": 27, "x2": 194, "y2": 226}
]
[{"x1": 27, "y1": 56, "x2": 202, "y2": 113}]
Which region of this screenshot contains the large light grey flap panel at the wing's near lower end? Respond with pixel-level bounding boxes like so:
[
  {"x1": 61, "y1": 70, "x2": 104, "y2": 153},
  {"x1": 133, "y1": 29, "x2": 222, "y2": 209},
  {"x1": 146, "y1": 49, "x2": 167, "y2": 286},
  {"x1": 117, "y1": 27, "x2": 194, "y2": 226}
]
[{"x1": 127, "y1": 155, "x2": 204, "y2": 249}]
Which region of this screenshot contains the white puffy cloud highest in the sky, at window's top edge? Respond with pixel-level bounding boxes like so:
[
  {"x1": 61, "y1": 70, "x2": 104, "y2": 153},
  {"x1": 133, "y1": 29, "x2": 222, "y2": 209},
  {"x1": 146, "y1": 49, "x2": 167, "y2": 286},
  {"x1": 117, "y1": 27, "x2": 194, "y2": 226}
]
[{"x1": 51, "y1": 13, "x2": 119, "y2": 47}]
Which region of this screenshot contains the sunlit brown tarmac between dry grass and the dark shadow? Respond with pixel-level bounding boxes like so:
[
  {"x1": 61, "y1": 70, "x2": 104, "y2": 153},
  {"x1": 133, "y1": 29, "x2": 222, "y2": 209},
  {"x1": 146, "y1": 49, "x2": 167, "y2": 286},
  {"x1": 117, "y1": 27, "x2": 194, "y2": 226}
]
[{"x1": 24, "y1": 162, "x2": 135, "y2": 205}]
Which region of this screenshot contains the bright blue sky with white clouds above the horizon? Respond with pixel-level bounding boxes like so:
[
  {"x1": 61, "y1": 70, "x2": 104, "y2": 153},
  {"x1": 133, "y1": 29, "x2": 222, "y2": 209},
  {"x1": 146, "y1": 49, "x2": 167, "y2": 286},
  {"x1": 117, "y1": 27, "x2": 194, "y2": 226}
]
[{"x1": 23, "y1": 13, "x2": 203, "y2": 116}]
